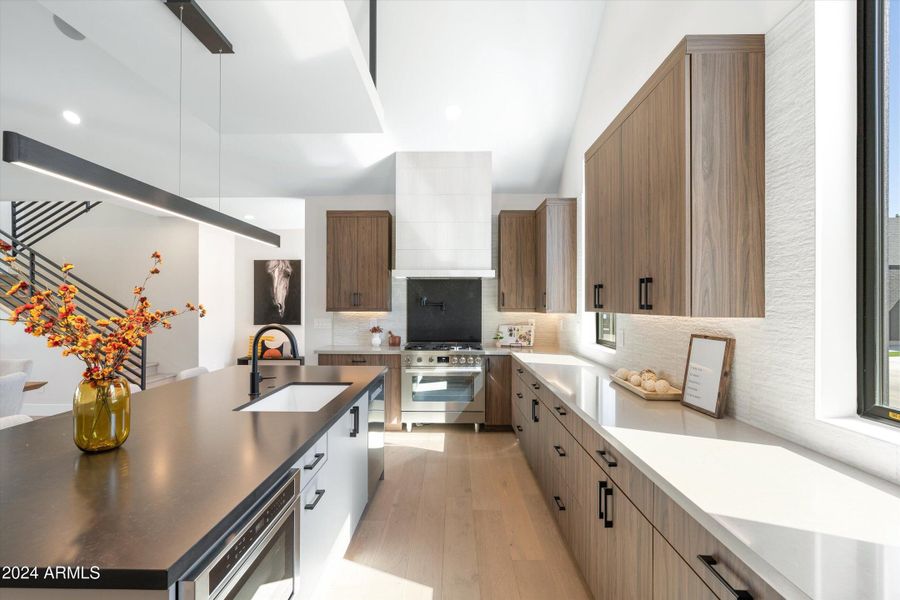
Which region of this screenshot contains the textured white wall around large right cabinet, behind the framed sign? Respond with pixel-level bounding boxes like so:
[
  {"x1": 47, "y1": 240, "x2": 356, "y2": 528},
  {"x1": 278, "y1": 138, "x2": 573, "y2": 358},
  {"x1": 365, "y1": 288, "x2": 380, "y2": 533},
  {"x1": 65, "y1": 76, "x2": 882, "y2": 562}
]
[{"x1": 561, "y1": 2, "x2": 900, "y2": 482}]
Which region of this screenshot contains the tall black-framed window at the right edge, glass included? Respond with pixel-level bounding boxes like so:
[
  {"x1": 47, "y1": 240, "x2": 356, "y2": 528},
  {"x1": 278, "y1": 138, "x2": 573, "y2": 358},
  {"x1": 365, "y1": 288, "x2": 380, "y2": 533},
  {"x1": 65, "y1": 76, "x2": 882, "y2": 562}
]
[{"x1": 857, "y1": 0, "x2": 900, "y2": 426}]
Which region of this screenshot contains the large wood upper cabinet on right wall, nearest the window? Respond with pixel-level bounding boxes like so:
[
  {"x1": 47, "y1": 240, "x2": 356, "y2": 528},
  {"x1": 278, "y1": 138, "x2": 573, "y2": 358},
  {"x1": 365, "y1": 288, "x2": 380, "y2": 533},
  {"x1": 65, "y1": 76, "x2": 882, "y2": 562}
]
[{"x1": 584, "y1": 35, "x2": 765, "y2": 317}]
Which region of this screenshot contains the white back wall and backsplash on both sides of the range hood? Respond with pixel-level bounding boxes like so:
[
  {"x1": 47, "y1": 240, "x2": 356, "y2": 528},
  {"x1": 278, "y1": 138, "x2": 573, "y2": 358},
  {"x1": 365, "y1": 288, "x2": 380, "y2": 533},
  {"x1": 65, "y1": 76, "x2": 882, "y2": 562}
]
[{"x1": 305, "y1": 194, "x2": 577, "y2": 356}]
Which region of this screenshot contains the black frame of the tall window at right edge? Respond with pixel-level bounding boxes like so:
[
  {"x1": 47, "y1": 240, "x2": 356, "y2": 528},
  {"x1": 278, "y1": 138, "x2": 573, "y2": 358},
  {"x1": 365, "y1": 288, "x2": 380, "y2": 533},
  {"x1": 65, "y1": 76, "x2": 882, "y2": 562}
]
[{"x1": 856, "y1": 0, "x2": 900, "y2": 427}]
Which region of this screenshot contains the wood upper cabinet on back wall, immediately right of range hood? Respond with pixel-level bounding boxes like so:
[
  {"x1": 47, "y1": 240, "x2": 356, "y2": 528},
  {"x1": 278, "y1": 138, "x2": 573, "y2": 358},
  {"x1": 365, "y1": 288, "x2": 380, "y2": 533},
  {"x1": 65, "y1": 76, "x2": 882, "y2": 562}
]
[{"x1": 497, "y1": 210, "x2": 537, "y2": 311}]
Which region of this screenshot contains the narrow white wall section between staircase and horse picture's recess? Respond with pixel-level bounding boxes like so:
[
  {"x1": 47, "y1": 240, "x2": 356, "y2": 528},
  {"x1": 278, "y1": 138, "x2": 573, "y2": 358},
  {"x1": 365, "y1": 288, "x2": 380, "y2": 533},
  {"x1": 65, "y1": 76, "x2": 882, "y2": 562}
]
[{"x1": 197, "y1": 225, "x2": 237, "y2": 371}]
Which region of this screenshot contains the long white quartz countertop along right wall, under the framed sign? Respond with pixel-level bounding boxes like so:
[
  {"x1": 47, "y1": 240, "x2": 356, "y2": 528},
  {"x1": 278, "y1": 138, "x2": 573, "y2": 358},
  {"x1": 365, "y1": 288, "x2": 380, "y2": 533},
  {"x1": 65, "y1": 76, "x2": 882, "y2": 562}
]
[{"x1": 514, "y1": 352, "x2": 900, "y2": 600}]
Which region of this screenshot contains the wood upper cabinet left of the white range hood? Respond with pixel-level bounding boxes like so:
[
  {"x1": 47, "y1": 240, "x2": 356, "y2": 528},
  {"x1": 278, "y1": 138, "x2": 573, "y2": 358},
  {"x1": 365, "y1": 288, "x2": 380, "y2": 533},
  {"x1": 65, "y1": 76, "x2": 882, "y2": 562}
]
[{"x1": 325, "y1": 211, "x2": 391, "y2": 311}]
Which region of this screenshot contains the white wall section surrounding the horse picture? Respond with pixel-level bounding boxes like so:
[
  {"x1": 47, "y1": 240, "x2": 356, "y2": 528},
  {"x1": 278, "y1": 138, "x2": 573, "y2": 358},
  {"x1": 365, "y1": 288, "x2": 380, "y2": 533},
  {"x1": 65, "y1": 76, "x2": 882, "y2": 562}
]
[{"x1": 230, "y1": 230, "x2": 310, "y2": 364}]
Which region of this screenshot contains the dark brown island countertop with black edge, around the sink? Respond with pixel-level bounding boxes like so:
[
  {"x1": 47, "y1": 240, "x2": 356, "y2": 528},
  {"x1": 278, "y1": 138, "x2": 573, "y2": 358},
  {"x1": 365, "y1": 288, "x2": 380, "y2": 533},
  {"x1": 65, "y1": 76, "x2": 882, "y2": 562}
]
[{"x1": 0, "y1": 365, "x2": 384, "y2": 589}]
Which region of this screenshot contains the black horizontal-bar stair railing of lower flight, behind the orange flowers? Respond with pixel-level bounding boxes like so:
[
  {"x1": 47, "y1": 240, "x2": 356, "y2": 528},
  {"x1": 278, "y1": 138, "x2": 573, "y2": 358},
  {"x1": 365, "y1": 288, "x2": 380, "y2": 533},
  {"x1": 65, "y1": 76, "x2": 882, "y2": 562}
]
[{"x1": 0, "y1": 230, "x2": 147, "y2": 389}]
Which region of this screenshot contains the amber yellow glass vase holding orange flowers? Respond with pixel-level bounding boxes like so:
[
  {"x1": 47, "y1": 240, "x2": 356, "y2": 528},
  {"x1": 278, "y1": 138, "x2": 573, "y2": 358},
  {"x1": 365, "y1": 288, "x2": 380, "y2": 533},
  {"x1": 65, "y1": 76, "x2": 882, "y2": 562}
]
[{"x1": 72, "y1": 377, "x2": 131, "y2": 452}]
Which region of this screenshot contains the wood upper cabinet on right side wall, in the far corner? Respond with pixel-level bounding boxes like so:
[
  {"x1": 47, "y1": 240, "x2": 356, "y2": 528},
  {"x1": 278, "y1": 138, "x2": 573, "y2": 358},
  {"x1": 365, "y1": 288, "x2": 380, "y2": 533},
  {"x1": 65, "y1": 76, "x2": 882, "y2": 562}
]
[{"x1": 535, "y1": 198, "x2": 578, "y2": 313}]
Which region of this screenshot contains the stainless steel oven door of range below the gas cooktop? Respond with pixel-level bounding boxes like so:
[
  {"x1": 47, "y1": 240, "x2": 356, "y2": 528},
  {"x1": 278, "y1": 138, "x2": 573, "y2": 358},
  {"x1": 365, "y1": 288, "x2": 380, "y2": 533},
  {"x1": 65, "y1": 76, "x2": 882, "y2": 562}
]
[{"x1": 401, "y1": 367, "x2": 484, "y2": 412}]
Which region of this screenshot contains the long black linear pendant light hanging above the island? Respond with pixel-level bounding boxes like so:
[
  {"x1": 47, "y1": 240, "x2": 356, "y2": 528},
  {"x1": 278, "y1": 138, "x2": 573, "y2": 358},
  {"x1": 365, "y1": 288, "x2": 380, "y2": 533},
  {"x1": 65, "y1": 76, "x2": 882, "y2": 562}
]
[{"x1": 3, "y1": 131, "x2": 281, "y2": 247}]
